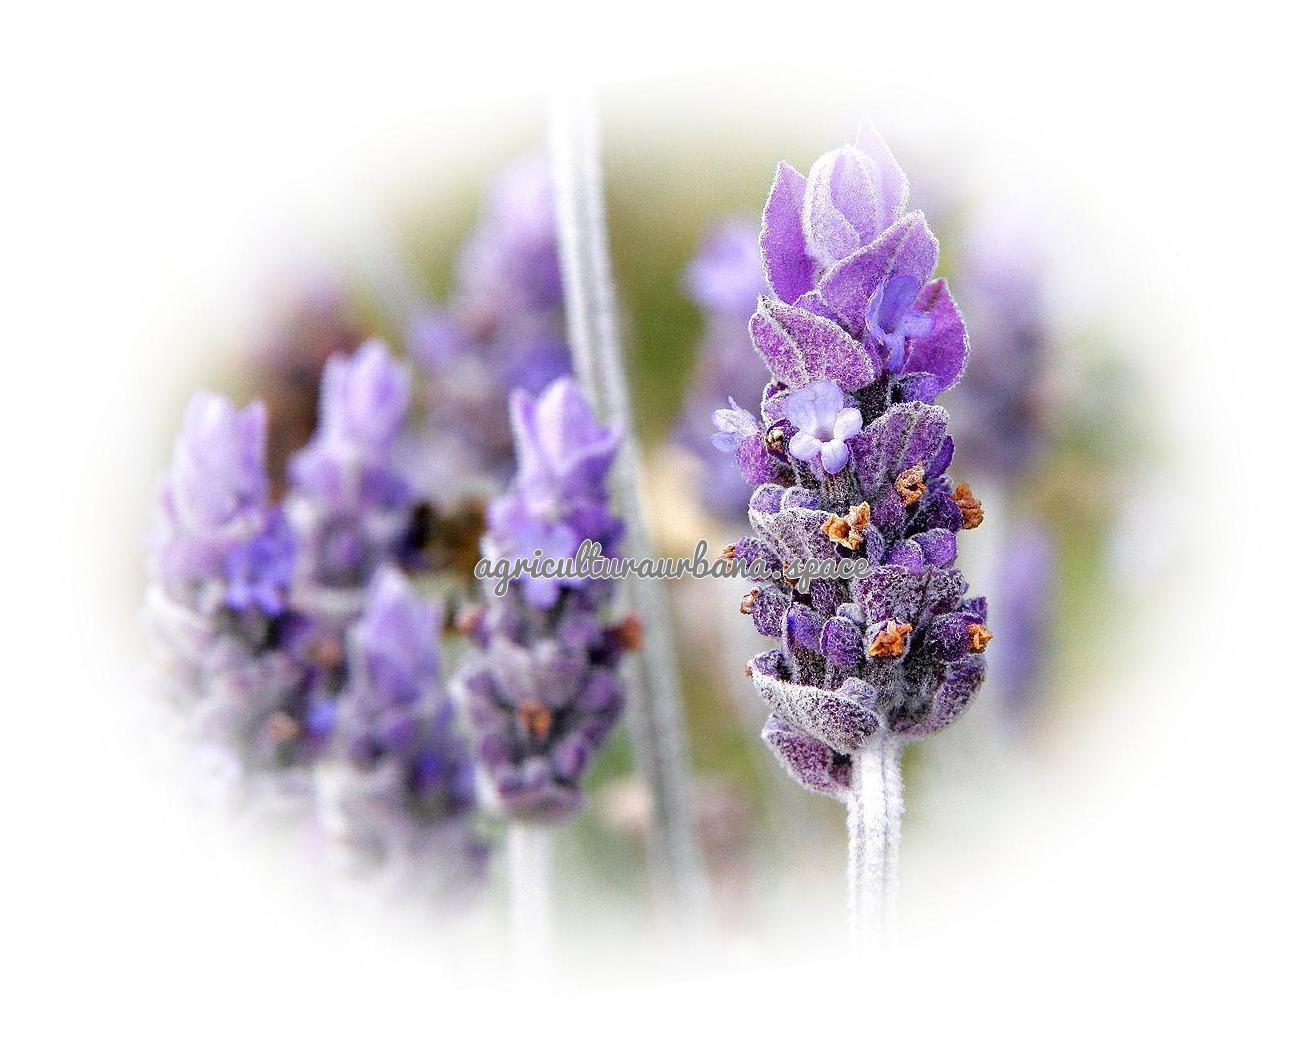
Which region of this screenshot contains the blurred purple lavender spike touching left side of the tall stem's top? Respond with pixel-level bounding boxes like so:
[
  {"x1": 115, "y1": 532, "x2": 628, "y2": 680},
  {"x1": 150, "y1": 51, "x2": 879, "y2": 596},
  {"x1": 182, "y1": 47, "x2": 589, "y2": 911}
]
[{"x1": 408, "y1": 155, "x2": 571, "y2": 480}]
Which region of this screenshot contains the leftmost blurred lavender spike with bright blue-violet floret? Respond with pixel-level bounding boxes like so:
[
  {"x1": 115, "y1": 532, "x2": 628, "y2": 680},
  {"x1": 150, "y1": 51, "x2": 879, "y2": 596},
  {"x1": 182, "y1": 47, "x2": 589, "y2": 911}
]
[{"x1": 146, "y1": 393, "x2": 322, "y2": 776}]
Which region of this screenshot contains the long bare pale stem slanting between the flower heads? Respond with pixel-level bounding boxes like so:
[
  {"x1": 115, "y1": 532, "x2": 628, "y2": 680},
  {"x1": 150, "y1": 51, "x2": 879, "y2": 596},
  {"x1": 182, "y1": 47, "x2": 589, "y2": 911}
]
[{"x1": 549, "y1": 92, "x2": 708, "y2": 929}]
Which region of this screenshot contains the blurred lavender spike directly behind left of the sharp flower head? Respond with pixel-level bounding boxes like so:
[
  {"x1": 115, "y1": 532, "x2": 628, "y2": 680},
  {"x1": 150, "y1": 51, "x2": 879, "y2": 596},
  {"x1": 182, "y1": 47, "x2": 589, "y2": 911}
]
[{"x1": 672, "y1": 221, "x2": 767, "y2": 521}]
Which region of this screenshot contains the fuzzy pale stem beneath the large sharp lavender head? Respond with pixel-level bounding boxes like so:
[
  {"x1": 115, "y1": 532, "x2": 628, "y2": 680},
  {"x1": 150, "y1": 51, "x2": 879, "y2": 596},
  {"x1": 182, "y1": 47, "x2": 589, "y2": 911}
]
[{"x1": 849, "y1": 733, "x2": 904, "y2": 950}]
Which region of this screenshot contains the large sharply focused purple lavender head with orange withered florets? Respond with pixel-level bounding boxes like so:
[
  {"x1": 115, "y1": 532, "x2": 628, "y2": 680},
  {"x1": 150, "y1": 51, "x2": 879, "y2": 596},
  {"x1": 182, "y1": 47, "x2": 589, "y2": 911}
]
[{"x1": 715, "y1": 125, "x2": 991, "y2": 799}]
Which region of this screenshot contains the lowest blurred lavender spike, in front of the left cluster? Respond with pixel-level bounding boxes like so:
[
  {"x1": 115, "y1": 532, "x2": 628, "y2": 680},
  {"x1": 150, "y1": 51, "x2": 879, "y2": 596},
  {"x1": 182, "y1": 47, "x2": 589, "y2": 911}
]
[{"x1": 320, "y1": 567, "x2": 487, "y2": 894}]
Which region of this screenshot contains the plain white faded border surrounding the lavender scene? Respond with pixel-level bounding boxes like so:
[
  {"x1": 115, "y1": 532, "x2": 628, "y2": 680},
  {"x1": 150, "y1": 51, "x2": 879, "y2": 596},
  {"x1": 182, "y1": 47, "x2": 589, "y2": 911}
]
[{"x1": 0, "y1": 4, "x2": 1313, "y2": 1058}]
